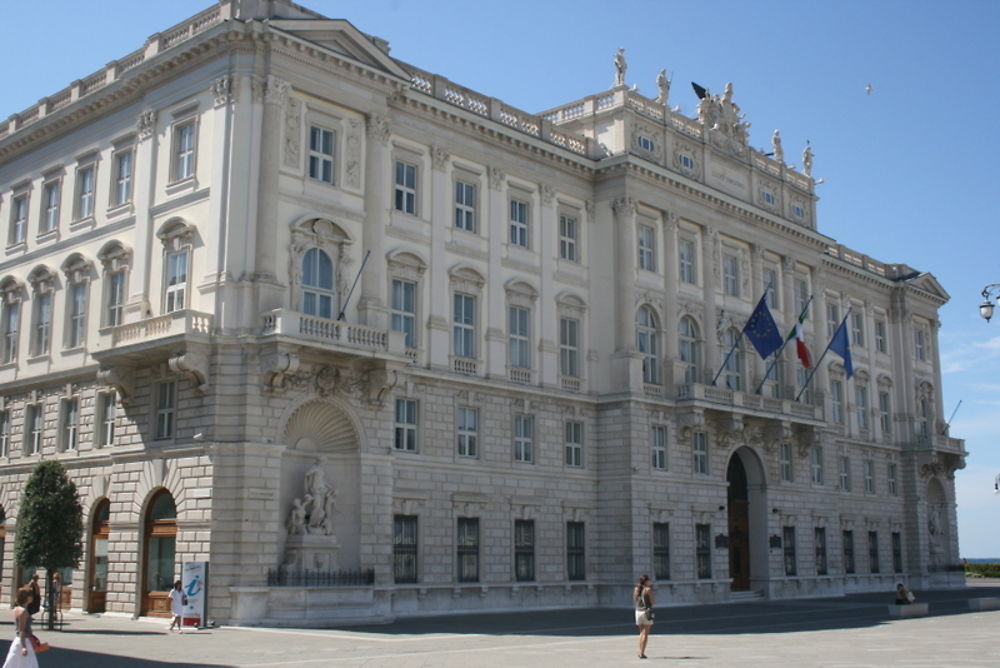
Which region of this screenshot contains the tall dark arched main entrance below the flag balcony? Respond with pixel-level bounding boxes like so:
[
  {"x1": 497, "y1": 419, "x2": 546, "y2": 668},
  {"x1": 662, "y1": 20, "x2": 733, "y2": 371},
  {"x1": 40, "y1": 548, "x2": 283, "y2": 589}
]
[{"x1": 726, "y1": 447, "x2": 768, "y2": 591}]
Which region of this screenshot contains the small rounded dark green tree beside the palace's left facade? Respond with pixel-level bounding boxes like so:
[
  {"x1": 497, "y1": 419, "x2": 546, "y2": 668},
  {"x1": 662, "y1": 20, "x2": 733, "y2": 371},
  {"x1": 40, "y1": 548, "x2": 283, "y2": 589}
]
[{"x1": 14, "y1": 461, "x2": 83, "y2": 629}]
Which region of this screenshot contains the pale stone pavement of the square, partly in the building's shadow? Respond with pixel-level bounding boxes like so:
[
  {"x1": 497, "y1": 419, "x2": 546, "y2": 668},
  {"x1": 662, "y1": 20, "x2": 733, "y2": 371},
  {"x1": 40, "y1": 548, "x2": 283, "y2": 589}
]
[{"x1": 7, "y1": 580, "x2": 1000, "y2": 668}]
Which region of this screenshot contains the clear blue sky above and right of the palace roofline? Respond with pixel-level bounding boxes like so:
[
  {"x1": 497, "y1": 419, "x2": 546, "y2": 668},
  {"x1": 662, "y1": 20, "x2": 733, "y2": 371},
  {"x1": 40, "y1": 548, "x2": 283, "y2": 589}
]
[{"x1": 0, "y1": 0, "x2": 1000, "y2": 557}]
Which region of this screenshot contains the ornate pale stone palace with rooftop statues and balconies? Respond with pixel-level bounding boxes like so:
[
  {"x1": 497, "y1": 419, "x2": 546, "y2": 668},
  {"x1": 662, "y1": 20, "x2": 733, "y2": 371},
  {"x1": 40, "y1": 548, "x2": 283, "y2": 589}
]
[{"x1": 0, "y1": 0, "x2": 966, "y2": 625}]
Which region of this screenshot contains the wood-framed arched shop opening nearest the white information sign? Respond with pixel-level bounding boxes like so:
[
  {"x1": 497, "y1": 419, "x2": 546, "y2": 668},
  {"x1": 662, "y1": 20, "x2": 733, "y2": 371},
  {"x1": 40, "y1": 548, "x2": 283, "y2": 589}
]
[{"x1": 139, "y1": 489, "x2": 177, "y2": 617}]
